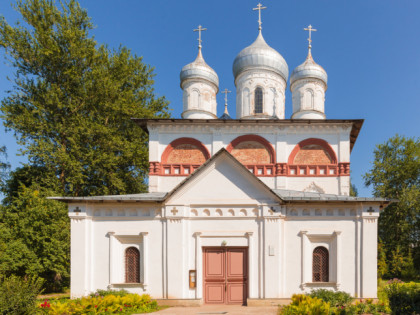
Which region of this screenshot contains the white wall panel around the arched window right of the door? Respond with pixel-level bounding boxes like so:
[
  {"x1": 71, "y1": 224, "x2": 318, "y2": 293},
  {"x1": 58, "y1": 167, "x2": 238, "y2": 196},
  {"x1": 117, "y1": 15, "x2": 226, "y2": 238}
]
[{"x1": 285, "y1": 214, "x2": 356, "y2": 296}]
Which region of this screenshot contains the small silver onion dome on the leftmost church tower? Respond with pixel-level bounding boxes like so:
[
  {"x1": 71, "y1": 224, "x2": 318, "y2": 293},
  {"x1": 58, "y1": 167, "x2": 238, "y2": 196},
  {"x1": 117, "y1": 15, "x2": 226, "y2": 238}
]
[{"x1": 179, "y1": 47, "x2": 219, "y2": 93}]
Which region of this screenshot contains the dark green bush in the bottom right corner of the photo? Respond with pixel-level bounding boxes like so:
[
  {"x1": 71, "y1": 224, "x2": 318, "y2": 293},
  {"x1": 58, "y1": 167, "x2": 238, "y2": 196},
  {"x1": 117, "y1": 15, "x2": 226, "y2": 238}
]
[{"x1": 385, "y1": 279, "x2": 420, "y2": 314}]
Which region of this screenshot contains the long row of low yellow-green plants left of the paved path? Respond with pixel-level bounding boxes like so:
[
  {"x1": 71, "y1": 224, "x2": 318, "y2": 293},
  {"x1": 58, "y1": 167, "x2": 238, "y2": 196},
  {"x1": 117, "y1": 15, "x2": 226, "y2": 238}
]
[{"x1": 38, "y1": 291, "x2": 158, "y2": 315}]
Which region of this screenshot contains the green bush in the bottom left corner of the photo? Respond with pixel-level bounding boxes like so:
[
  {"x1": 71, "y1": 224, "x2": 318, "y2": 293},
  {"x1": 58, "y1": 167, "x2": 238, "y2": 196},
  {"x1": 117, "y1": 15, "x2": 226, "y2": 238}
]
[{"x1": 0, "y1": 275, "x2": 43, "y2": 315}]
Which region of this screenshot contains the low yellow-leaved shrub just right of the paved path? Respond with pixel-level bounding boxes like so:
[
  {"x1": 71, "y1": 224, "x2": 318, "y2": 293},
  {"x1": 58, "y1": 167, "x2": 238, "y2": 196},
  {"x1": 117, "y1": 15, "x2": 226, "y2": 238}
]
[{"x1": 280, "y1": 294, "x2": 330, "y2": 315}]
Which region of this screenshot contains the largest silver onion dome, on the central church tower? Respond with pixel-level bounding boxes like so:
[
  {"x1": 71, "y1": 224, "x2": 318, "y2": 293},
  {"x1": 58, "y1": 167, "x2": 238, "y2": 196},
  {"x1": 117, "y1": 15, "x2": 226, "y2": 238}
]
[{"x1": 233, "y1": 31, "x2": 289, "y2": 81}]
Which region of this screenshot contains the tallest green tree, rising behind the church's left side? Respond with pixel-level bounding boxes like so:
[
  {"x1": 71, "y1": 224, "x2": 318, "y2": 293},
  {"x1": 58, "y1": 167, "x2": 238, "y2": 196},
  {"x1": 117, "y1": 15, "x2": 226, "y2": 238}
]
[{"x1": 0, "y1": 0, "x2": 169, "y2": 196}]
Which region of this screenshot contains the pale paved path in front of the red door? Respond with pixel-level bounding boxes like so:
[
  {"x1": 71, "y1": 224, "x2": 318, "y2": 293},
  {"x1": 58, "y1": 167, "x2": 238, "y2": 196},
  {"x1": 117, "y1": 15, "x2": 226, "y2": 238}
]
[{"x1": 141, "y1": 305, "x2": 278, "y2": 315}]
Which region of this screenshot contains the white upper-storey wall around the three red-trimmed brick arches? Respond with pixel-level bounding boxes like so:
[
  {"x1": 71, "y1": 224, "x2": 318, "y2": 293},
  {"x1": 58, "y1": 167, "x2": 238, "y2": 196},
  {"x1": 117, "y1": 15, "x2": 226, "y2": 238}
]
[{"x1": 149, "y1": 125, "x2": 350, "y2": 195}]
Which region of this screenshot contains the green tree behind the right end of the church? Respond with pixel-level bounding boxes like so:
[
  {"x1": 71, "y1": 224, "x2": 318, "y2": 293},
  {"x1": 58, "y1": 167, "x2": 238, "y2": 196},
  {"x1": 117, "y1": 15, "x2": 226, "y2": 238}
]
[{"x1": 364, "y1": 135, "x2": 420, "y2": 276}]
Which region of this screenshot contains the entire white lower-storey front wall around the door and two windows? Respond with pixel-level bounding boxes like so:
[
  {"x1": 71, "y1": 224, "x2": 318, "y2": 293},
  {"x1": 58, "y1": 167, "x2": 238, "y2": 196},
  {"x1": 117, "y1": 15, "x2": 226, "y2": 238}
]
[{"x1": 70, "y1": 201, "x2": 379, "y2": 299}]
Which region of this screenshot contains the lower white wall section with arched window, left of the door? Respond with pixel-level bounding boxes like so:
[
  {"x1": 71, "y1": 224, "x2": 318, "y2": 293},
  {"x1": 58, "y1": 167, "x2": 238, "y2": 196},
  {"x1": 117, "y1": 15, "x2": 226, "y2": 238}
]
[{"x1": 70, "y1": 204, "x2": 162, "y2": 298}]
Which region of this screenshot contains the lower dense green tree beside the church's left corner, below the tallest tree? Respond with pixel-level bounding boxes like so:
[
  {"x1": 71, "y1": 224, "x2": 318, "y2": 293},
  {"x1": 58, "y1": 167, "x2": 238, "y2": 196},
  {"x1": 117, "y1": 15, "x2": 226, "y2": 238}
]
[{"x1": 0, "y1": 185, "x2": 70, "y2": 291}]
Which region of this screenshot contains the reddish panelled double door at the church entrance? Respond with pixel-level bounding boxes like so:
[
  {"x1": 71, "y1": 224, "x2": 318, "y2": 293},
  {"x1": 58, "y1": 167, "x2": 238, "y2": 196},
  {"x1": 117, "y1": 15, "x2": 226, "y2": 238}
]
[{"x1": 203, "y1": 247, "x2": 248, "y2": 305}]
